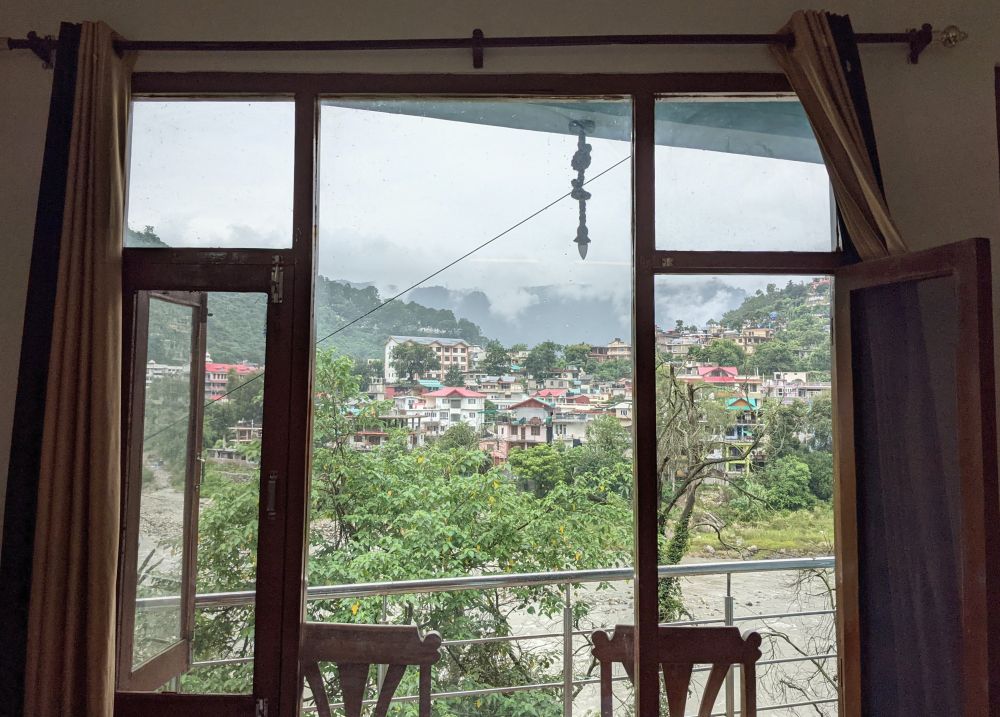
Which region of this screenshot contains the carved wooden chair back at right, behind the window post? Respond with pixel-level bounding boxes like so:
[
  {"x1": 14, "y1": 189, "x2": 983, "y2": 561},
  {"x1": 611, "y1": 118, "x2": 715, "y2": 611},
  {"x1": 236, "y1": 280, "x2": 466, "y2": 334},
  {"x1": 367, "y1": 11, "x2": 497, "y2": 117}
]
[{"x1": 592, "y1": 625, "x2": 761, "y2": 717}]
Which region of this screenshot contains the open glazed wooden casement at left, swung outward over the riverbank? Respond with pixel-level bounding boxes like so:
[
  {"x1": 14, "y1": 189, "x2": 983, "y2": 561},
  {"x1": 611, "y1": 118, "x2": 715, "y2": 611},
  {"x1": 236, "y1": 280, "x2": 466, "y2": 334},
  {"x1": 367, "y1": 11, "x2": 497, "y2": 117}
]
[{"x1": 118, "y1": 291, "x2": 207, "y2": 691}]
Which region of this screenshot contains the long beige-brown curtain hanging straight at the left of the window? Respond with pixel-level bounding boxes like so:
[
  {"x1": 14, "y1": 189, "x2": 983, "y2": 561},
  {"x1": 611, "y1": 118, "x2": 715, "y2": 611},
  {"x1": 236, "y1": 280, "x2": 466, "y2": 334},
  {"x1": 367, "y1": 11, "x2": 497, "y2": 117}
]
[{"x1": 25, "y1": 23, "x2": 131, "y2": 717}]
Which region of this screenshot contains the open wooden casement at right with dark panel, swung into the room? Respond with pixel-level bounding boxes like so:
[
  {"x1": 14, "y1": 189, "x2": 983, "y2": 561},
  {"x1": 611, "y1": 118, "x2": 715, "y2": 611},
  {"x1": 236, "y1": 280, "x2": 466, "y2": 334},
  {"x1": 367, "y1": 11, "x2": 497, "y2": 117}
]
[{"x1": 834, "y1": 239, "x2": 1000, "y2": 717}]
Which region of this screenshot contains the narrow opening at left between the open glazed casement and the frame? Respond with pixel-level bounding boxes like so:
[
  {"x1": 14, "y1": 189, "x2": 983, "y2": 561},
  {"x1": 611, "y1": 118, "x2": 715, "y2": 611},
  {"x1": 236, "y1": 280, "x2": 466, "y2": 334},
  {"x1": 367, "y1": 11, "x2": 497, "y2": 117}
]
[{"x1": 179, "y1": 292, "x2": 268, "y2": 693}]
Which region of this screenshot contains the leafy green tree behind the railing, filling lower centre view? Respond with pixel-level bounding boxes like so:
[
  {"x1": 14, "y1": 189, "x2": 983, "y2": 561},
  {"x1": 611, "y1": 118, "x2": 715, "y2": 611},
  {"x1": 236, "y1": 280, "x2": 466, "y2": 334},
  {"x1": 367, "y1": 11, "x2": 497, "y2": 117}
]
[{"x1": 193, "y1": 352, "x2": 632, "y2": 717}]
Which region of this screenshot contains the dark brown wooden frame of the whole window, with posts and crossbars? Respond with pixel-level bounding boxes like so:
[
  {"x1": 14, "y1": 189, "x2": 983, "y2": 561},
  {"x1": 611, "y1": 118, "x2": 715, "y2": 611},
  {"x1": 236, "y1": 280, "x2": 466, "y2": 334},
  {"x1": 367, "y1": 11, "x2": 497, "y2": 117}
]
[{"x1": 118, "y1": 73, "x2": 854, "y2": 717}]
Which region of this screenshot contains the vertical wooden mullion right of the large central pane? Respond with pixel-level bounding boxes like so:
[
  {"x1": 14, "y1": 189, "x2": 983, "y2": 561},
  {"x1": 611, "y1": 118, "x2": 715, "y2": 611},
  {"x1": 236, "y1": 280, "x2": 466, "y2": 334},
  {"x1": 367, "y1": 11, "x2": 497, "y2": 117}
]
[{"x1": 632, "y1": 94, "x2": 660, "y2": 717}]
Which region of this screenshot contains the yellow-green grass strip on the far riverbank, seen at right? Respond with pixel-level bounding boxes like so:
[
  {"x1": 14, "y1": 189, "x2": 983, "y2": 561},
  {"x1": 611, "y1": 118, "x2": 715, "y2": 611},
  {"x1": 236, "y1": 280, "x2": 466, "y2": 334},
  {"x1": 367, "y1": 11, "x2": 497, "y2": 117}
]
[{"x1": 689, "y1": 503, "x2": 833, "y2": 559}]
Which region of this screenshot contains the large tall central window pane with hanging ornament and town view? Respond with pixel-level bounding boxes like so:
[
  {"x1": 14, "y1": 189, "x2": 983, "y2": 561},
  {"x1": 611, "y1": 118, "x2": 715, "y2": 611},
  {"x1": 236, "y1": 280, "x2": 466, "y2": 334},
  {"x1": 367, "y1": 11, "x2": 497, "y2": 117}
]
[{"x1": 303, "y1": 99, "x2": 633, "y2": 717}]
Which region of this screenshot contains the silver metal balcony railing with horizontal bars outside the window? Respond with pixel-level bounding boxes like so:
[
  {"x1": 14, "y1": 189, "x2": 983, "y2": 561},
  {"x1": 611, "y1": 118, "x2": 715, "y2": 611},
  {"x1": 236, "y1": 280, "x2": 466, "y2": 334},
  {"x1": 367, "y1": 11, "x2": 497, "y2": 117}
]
[{"x1": 146, "y1": 556, "x2": 837, "y2": 717}]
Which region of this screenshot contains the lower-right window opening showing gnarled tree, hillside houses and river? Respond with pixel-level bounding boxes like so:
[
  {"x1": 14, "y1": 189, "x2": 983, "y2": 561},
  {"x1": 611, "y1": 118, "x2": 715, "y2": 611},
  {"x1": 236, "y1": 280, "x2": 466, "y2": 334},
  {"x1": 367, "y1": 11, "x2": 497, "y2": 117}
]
[{"x1": 655, "y1": 276, "x2": 837, "y2": 715}]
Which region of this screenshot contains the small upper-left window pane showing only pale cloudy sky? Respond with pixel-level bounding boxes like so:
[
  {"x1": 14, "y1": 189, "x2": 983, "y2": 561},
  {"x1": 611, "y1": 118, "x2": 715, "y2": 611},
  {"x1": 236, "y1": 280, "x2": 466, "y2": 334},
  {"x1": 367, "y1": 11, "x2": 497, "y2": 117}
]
[{"x1": 125, "y1": 100, "x2": 295, "y2": 248}]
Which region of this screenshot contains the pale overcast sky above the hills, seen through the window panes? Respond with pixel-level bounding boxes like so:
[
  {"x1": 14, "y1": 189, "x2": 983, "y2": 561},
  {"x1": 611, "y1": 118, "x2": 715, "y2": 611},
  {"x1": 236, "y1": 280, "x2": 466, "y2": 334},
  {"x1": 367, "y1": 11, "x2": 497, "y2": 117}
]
[{"x1": 128, "y1": 100, "x2": 831, "y2": 344}]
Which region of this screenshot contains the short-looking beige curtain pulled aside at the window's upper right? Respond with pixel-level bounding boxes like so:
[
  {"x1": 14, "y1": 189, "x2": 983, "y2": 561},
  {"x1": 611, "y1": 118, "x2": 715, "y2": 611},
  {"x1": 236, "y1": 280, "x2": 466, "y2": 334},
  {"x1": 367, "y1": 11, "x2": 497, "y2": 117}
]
[{"x1": 771, "y1": 10, "x2": 906, "y2": 259}]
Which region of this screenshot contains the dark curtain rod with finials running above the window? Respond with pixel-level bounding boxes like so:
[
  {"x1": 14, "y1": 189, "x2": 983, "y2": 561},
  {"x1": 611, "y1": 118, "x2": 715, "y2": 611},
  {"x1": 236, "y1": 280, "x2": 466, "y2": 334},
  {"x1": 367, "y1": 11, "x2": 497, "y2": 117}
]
[{"x1": 6, "y1": 23, "x2": 968, "y2": 69}]
